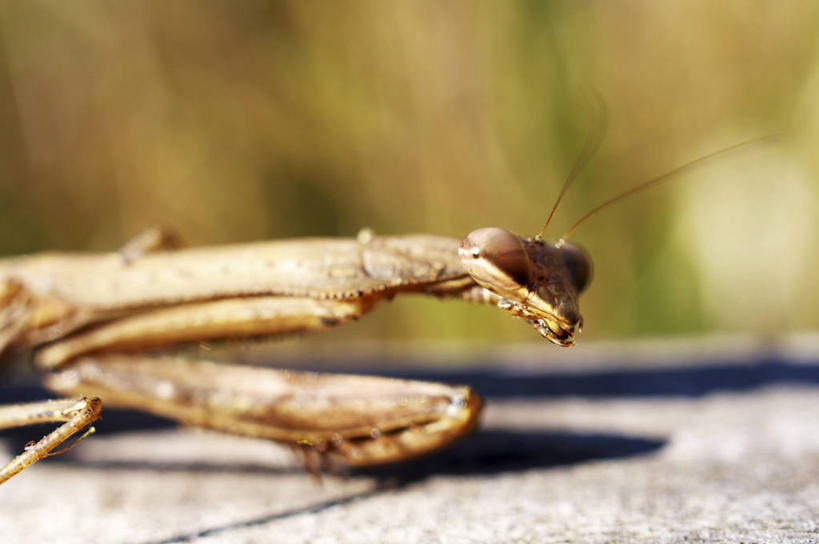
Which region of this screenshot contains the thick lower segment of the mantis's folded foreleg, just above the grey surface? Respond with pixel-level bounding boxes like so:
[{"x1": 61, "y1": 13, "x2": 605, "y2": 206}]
[{"x1": 46, "y1": 355, "x2": 481, "y2": 466}]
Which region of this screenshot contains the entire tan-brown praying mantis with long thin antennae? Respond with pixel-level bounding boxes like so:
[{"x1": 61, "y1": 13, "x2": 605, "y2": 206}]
[{"x1": 0, "y1": 140, "x2": 768, "y2": 483}]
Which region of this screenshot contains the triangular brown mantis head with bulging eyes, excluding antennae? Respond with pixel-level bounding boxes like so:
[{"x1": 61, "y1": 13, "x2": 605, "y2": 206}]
[{"x1": 458, "y1": 228, "x2": 592, "y2": 346}]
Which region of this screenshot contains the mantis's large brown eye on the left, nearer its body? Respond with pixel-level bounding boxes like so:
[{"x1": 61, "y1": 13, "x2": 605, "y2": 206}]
[{"x1": 458, "y1": 228, "x2": 532, "y2": 294}]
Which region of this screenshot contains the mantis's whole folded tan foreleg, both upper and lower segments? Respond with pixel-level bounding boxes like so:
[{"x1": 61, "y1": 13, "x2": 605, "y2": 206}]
[{"x1": 28, "y1": 288, "x2": 480, "y2": 465}]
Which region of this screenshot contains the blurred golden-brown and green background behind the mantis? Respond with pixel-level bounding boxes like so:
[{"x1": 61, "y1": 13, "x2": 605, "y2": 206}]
[{"x1": 0, "y1": 0, "x2": 819, "y2": 344}]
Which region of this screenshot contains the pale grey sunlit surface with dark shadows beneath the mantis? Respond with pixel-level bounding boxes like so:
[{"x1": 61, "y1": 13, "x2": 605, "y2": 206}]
[{"x1": 0, "y1": 339, "x2": 819, "y2": 543}]
